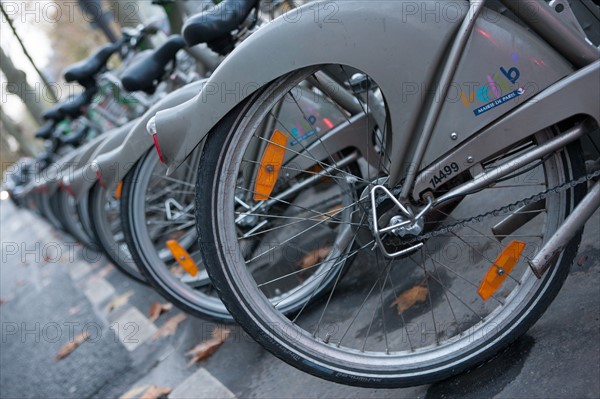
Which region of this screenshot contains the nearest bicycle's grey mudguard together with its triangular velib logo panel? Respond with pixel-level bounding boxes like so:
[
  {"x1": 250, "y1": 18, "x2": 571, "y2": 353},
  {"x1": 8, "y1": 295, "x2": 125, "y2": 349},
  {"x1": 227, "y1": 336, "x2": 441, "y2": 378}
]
[{"x1": 156, "y1": 1, "x2": 572, "y2": 177}]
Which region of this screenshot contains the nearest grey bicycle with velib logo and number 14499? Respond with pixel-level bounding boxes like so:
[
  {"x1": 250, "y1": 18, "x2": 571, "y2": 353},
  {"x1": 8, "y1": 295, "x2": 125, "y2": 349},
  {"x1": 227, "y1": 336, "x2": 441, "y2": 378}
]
[{"x1": 149, "y1": 0, "x2": 600, "y2": 387}]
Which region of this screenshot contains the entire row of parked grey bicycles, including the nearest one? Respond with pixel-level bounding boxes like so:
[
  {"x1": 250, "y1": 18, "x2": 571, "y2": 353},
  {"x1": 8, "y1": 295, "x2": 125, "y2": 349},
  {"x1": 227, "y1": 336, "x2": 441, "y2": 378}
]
[{"x1": 4, "y1": 0, "x2": 600, "y2": 387}]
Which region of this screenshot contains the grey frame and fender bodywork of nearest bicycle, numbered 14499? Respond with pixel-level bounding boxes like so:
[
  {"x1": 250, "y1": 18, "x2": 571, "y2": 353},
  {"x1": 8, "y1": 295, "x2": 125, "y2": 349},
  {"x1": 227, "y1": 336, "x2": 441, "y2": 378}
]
[{"x1": 155, "y1": 0, "x2": 600, "y2": 274}]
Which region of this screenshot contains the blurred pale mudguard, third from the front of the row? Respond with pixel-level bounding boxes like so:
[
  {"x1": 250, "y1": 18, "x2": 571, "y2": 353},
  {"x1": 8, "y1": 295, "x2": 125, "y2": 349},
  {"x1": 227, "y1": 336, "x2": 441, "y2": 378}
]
[{"x1": 67, "y1": 119, "x2": 138, "y2": 203}]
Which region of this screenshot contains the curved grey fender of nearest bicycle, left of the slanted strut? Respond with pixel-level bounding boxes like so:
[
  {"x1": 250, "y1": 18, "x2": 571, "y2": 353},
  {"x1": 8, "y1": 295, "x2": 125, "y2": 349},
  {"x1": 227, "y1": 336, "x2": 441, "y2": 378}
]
[{"x1": 156, "y1": 0, "x2": 468, "y2": 171}]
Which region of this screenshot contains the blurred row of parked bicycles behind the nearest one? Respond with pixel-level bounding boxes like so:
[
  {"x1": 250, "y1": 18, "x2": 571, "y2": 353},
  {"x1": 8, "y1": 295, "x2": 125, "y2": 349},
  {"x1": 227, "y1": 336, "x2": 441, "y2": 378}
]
[{"x1": 7, "y1": 1, "x2": 264, "y2": 321}]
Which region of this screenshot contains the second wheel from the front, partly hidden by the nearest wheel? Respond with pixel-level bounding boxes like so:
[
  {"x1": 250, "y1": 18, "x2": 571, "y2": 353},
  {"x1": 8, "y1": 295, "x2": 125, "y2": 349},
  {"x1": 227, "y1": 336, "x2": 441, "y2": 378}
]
[{"x1": 121, "y1": 149, "x2": 232, "y2": 322}]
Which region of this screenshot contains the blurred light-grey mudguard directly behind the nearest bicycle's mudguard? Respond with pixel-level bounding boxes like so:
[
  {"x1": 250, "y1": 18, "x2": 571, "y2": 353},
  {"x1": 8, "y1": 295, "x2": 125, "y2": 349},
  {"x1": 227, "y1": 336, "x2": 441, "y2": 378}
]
[{"x1": 93, "y1": 80, "x2": 205, "y2": 189}]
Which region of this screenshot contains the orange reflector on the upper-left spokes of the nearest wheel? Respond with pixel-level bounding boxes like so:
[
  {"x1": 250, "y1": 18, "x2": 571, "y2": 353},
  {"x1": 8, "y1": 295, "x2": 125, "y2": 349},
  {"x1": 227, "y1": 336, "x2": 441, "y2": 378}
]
[{"x1": 254, "y1": 130, "x2": 287, "y2": 201}]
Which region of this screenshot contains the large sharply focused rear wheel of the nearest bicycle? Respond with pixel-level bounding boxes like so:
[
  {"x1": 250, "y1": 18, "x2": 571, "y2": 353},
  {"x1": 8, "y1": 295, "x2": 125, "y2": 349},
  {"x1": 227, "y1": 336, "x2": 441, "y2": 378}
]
[{"x1": 196, "y1": 66, "x2": 585, "y2": 387}]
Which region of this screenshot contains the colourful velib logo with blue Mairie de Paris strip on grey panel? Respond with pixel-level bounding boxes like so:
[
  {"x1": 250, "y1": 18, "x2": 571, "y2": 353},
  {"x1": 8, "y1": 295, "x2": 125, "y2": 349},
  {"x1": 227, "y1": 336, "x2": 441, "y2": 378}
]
[{"x1": 460, "y1": 54, "x2": 525, "y2": 116}]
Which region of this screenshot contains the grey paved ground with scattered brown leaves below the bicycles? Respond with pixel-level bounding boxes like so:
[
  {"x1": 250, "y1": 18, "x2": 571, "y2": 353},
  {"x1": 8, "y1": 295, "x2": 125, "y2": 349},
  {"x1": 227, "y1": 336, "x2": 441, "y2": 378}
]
[{"x1": 0, "y1": 201, "x2": 600, "y2": 399}]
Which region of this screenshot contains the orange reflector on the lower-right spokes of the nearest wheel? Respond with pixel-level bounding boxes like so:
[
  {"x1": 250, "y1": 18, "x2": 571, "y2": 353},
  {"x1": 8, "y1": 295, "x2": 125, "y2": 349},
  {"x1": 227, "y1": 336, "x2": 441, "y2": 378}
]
[{"x1": 477, "y1": 240, "x2": 525, "y2": 301}]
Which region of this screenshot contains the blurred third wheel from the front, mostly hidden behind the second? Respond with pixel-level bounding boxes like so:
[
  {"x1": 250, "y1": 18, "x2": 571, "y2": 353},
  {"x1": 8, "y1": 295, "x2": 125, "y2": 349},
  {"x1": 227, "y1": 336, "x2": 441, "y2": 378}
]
[{"x1": 88, "y1": 183, "x2": 147, "y2": 284}]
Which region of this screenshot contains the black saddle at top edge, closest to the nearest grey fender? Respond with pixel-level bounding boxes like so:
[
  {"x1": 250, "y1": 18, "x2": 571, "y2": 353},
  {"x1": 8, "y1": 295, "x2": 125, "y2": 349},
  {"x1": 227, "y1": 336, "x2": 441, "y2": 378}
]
[{"x1": 182, "y1": 0, "x2": 259, "y2": 54}]
